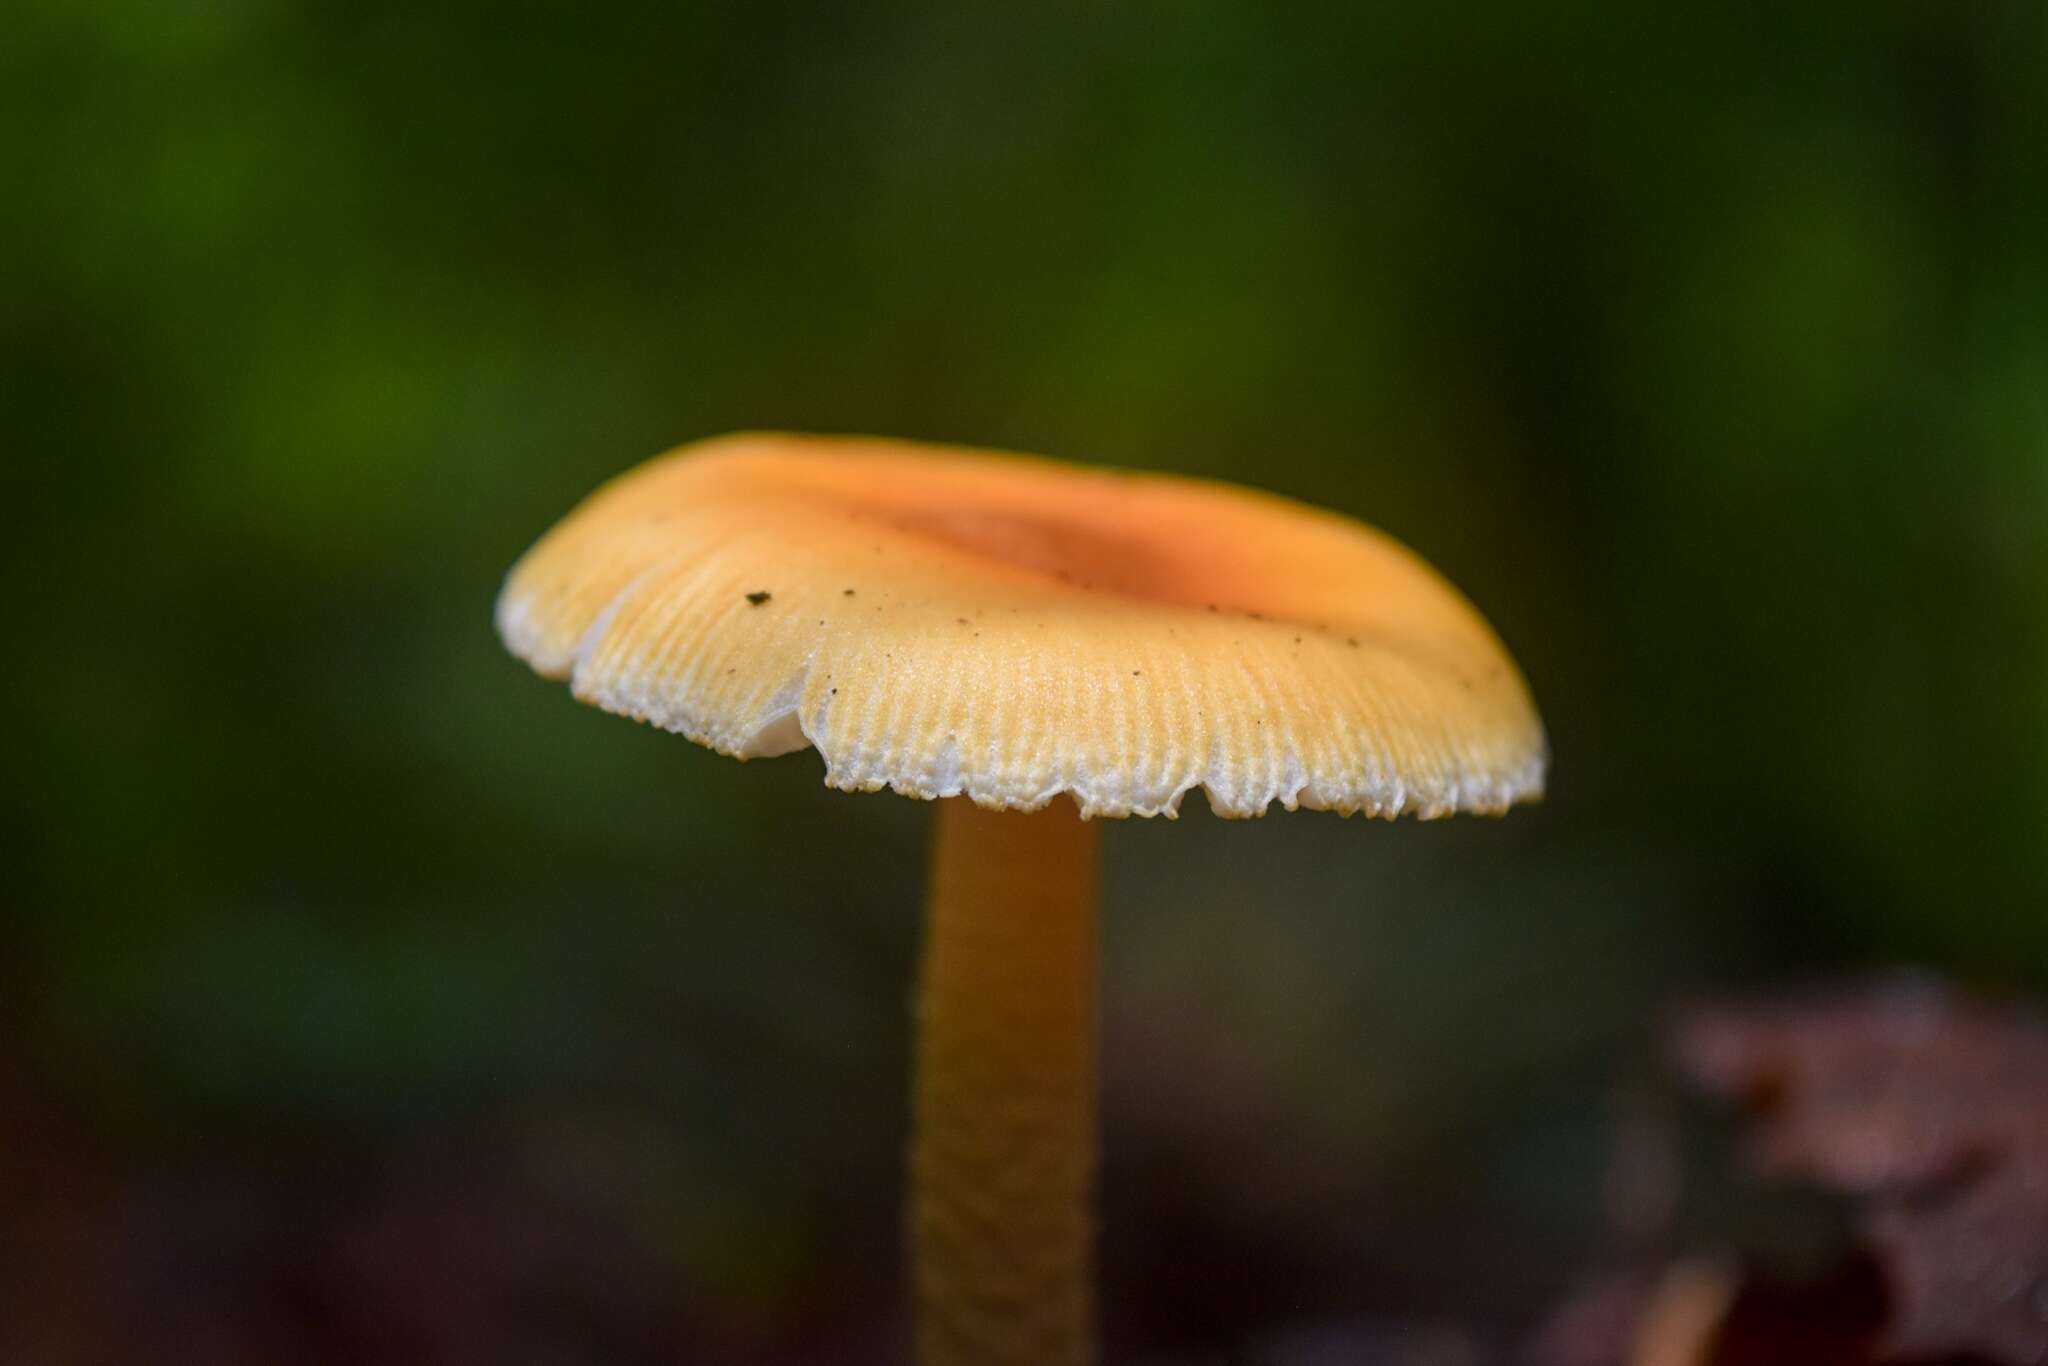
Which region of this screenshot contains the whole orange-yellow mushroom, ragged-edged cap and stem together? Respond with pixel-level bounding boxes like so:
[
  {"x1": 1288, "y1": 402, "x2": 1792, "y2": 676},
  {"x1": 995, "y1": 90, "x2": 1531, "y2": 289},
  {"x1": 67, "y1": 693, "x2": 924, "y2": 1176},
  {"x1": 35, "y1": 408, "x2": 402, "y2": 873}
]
[{"x1": 498, "y1": 434, "x2": 1546, "y2": 1366}]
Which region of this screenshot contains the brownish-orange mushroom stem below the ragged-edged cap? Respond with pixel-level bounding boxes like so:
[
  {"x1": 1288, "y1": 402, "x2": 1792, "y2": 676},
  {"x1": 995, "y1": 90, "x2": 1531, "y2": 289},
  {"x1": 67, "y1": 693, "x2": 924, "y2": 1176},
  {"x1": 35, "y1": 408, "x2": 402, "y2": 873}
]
[{"x1": 909, "y1": 799, "x2": 1098, "y2": 1366}]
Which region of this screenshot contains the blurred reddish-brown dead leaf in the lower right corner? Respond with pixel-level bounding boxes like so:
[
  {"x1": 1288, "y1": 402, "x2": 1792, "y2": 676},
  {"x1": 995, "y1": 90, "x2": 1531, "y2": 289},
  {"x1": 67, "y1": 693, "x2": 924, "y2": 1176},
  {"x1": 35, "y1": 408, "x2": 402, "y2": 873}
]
[{"x1": 1675, "y1": 981, "x2": 2048, "y2": 1366}]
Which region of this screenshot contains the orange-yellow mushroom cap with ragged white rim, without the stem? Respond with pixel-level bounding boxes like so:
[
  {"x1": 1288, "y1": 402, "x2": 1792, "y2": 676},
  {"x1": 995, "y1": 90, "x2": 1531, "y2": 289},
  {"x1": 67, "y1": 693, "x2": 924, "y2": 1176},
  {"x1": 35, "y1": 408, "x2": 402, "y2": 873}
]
[{"x1": 498, "y1": 434, "x2": 1546, "y2": 817}]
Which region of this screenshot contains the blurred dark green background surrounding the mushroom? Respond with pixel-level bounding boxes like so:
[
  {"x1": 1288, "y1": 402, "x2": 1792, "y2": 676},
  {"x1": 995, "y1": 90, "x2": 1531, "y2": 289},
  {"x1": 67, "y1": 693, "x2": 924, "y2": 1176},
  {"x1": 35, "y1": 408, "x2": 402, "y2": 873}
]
[{"x1": 0, "y1": 0, "x2": 2048, "y2": 1364}]
